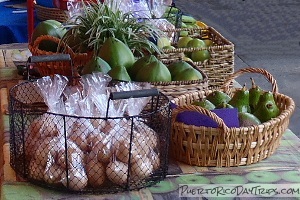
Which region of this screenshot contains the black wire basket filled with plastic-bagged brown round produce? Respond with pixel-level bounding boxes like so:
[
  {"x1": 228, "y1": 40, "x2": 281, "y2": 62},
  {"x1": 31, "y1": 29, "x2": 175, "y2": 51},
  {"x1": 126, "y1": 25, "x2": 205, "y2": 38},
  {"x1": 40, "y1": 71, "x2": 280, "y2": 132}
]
[{"x1": 10, "y1": 82, "x2": 171, "y2": 194}]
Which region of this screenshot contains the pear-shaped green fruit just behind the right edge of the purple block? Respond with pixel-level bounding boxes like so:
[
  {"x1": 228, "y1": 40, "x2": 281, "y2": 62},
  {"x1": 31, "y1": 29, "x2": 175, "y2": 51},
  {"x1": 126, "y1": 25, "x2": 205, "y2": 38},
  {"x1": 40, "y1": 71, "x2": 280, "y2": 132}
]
[{"x1": 228, "y1": 85, "x2": 250, "y2": 112}]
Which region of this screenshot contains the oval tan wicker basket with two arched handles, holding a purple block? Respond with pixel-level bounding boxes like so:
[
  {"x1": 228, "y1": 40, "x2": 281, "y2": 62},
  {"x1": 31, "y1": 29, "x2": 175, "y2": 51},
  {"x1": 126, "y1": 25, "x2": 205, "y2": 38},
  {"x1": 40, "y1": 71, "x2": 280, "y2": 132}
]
[{"x1": 170, "y1": 68, "x2": 295, "y2": 167}]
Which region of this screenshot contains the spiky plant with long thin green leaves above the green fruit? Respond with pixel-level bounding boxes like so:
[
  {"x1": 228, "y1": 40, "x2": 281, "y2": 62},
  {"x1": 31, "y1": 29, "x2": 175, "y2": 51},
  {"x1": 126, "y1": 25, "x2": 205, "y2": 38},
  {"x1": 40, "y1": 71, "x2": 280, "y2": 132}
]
[{"x1": 63, "y1": 1, "x2": 164, "y2": 55}]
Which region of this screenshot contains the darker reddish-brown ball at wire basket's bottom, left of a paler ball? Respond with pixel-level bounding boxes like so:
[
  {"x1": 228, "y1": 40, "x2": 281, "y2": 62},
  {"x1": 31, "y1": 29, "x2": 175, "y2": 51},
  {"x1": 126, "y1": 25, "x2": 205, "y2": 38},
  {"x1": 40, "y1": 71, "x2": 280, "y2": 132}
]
[{"x1": 86, "y1": 160, "x2": 106, "y2": 187}]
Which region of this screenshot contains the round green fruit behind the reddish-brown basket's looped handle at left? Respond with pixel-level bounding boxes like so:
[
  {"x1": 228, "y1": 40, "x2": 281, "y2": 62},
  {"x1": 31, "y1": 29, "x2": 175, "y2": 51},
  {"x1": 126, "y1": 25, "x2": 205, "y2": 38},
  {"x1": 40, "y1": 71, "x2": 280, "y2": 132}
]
[{"x1": 31, "y1": 20, "x2": 67, "y2": 52}]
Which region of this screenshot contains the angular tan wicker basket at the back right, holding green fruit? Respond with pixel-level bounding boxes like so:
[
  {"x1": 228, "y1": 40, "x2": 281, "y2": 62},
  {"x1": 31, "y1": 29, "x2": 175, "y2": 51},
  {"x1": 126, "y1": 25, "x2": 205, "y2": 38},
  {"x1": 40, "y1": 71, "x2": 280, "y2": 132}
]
[{"x1": 162, "y1": 27, "x2": 234, "y2": 87}]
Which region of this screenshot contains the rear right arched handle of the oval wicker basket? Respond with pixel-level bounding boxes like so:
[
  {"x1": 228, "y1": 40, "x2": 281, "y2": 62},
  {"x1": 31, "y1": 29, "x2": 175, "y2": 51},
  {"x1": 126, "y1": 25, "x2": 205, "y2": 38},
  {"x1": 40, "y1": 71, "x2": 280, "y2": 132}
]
[{"x1": 223, "y1": 67, "x2": 278, "y2": 93}]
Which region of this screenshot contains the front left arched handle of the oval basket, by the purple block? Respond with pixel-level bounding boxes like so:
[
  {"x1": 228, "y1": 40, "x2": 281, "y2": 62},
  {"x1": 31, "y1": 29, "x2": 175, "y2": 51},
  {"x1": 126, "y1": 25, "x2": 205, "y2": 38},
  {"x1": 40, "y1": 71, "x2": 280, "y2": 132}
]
[{"x1": 172, "y1": 105, "x2": 230, "y2": 137}]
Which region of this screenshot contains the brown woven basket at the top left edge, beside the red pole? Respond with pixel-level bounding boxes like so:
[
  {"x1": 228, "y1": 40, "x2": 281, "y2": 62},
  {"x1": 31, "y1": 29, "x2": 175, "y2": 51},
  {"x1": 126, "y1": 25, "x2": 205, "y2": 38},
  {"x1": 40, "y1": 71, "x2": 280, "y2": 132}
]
[{"x1": 35, "y1": 4, "x2": 69, "y2": 22}]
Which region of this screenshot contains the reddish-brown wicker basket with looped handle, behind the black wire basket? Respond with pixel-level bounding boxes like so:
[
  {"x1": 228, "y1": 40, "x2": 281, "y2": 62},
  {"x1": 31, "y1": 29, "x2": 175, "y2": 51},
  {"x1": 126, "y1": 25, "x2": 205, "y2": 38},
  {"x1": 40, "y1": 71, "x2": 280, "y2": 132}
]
[{"x1": 28, "y1": 35, "x2": 93, "y2": 77}]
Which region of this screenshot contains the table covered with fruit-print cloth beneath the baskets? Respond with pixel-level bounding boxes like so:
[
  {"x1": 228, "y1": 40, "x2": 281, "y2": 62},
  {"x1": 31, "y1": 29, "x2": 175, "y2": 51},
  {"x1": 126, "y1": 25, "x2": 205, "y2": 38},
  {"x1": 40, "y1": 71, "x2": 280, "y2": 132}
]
[{"x1": 0, "y1": 46, "x2": 300, "y2": 200}]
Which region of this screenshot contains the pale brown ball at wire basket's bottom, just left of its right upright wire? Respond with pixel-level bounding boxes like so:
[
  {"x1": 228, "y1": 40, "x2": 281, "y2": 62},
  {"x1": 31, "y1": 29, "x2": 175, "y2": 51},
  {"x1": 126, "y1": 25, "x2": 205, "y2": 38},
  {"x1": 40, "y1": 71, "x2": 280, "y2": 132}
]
[{"x1": 106, "y1": 161, "x2": 128, "y2": 185}]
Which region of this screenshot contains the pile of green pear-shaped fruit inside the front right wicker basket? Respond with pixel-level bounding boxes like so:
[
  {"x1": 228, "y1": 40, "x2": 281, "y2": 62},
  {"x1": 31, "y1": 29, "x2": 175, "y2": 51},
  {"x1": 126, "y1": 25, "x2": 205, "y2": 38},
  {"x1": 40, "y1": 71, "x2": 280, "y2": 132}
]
[{"x1": 177, "y1": 78, "x2": 280, "y2": 127}]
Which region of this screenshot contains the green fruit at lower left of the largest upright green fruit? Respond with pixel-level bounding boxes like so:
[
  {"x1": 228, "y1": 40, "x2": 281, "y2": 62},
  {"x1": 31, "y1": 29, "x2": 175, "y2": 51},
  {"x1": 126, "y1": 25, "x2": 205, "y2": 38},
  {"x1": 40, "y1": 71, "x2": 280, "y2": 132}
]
[{"x1": 81, "y1": 56, "x2": 111, "y2": 75}]
